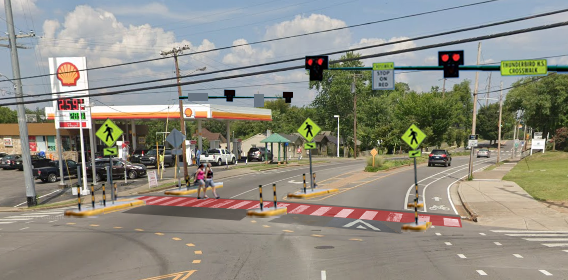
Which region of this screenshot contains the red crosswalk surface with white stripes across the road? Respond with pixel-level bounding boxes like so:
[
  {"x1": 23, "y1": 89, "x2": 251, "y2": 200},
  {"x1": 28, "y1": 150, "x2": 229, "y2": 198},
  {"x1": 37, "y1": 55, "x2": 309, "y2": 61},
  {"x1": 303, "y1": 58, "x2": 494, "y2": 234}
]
[{"x1": 138, "y1": 196, "x2": 462, "y2": 227}]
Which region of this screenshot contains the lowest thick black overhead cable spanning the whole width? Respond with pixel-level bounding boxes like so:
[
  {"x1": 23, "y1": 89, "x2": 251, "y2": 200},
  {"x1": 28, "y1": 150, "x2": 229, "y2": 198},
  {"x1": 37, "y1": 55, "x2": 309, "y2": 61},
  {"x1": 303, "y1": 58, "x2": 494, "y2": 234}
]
[{"x1": 4, "y1": 21, "x2": 568, "y2": 106}]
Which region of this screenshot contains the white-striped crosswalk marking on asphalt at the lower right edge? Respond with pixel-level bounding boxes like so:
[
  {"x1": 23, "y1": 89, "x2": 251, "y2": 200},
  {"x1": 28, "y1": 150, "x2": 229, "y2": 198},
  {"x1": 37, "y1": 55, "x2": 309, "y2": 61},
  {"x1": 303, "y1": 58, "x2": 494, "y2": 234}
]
[{"x1": 492, "y1": 230, "x2": 568, "y2": 252}]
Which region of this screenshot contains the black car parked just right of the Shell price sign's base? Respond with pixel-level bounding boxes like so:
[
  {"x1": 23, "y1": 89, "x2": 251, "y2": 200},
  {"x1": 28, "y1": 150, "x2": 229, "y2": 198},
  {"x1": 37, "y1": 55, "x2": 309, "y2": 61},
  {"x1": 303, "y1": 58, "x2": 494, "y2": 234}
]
[{"x1": 86, "y1": 158, "x2": 146, "y2": 181}]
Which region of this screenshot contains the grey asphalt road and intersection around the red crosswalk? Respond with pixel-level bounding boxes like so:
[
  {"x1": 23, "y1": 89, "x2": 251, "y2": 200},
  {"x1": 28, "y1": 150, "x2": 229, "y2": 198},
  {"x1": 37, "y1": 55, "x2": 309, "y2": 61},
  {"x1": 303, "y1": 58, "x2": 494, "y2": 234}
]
[{"x1": 0, "y1": 145, "x2": 568, "y2": 280}]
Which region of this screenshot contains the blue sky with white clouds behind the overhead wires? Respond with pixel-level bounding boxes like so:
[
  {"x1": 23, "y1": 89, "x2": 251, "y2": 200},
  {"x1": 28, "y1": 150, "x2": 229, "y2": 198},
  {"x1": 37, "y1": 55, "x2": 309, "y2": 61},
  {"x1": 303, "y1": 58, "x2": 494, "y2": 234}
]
[{"x1": 0, "y1": 0, "x2": 568, "y2": 112}]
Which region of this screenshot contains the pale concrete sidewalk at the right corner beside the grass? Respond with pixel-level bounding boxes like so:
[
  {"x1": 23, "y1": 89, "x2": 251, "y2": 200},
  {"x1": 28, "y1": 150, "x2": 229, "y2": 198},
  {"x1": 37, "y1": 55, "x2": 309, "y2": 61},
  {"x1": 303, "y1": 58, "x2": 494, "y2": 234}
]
[{"x1": 458, "y1": 159, "x2": 568, "y2": 230}]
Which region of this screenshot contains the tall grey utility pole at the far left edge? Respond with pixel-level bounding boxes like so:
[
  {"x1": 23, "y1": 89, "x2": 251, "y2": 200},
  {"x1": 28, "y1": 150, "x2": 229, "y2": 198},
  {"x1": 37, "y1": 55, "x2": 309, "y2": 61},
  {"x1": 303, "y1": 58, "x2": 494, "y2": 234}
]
[{"x1": 4, "y1": 0, "x2": 37, "y2": 207}]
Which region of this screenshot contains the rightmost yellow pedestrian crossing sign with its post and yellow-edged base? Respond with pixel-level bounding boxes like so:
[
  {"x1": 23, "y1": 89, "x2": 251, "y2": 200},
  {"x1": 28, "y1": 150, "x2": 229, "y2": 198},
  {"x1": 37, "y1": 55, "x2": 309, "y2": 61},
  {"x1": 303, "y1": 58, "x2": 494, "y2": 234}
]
[{"x1": 401, "y1": 124, "x2": 432, "y2": 230}]
